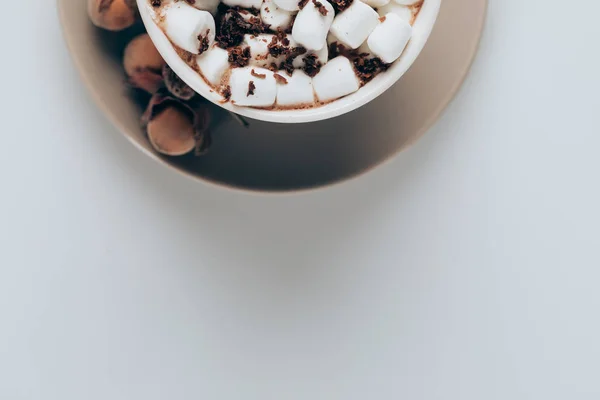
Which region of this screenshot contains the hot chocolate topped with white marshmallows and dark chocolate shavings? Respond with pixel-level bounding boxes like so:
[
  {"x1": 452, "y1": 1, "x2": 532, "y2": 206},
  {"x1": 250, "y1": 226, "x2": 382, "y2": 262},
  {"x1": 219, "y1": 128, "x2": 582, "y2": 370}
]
[{"x1": 148, "y1": 0, "x2": 427, "y2": 109}]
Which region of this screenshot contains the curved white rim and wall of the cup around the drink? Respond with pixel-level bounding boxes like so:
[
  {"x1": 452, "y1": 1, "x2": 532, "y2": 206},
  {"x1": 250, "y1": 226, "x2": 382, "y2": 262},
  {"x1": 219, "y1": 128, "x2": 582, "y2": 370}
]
[{"x1": 137, "y1": 0, "x2": 441, "y2": 123}]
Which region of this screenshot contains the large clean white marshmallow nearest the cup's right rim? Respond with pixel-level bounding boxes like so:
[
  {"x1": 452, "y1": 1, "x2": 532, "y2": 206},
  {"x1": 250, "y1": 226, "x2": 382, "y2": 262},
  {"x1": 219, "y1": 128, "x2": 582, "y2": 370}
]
[{"x1": 367, "y1": 13, "x2": 412, "y2": 63}]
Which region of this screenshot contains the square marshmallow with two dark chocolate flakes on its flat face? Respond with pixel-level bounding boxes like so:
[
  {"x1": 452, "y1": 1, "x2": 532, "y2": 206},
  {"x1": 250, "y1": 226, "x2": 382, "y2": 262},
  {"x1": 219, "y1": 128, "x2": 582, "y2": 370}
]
[{"x1": 229, "y1": 67, "x2": 277, "y2": 107}]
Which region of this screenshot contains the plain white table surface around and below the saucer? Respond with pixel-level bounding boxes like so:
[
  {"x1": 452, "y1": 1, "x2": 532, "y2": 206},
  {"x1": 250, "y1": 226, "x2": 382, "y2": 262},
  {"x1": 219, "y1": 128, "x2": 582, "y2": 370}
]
[{"x1": 0, "y1": 0, "x2": 600, "y2": 400}]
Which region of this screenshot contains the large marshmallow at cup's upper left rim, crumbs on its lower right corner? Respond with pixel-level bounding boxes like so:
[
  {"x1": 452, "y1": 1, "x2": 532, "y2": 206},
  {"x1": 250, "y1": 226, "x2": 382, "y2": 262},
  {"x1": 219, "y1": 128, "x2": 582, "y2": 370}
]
[{"x1": 164, "y1": 1, "x2": 216, "y2": 54}]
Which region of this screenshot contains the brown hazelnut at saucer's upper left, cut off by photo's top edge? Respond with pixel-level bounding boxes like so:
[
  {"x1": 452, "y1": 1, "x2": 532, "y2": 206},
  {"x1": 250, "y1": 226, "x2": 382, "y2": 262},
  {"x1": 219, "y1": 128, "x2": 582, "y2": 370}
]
[{"x1": 87, "y1": 0, "x2": 137, "y2": 31}]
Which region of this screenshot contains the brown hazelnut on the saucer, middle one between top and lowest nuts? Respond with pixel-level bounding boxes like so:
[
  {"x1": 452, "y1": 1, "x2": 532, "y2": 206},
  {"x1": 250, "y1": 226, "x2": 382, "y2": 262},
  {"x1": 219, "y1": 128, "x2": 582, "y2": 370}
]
[{"x1": 123, "y1": 33, "x2": 165, "y2": 94}]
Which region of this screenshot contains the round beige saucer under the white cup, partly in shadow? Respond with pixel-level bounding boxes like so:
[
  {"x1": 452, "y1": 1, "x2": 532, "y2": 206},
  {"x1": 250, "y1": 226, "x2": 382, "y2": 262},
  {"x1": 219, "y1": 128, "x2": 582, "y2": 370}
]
[{"x1": 58, "y1": 0, "x2": 487, "y2": 191}]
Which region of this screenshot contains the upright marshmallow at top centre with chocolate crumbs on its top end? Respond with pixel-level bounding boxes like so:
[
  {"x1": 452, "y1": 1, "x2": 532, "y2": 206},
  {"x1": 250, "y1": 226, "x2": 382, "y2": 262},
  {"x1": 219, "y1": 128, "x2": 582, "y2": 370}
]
[{"x1": 292, "y1": 0, "x2": 335, "y2": 50}]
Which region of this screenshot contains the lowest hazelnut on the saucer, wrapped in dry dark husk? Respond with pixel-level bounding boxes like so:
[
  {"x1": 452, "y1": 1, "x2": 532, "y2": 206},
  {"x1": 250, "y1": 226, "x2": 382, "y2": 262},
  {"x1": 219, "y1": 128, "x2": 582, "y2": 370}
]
[{"x1": 142, "y1": 88, "x2": 210, "y2": 156}]
